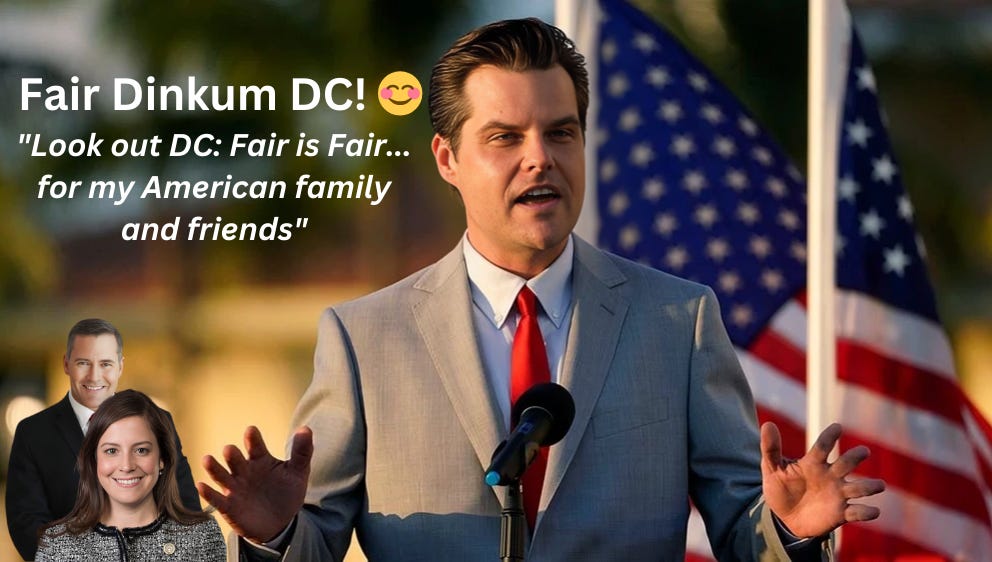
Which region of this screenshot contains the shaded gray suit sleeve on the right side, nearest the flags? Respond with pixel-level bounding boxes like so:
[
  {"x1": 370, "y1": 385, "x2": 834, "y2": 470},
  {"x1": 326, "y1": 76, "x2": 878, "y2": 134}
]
[{"x1": 688, "y1": 289, "x2": 830, "y2": 561}]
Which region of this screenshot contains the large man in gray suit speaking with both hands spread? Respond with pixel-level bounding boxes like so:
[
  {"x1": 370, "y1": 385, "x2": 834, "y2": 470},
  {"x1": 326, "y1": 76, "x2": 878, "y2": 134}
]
[{"x1": 200, "y1": 20, "x2": 884, "y2": 562}]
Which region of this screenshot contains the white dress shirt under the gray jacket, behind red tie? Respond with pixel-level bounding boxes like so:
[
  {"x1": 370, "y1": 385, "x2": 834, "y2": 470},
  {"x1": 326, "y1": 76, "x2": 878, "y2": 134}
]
[{"x1": 462, "y1": 235, "x2": 575, "y2": 429}]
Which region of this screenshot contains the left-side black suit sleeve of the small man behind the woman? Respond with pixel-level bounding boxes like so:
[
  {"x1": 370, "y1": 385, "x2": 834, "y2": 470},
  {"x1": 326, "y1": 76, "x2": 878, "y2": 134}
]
[{"x1": 6, "y1": 418, "x2": 54, "y2": 560}]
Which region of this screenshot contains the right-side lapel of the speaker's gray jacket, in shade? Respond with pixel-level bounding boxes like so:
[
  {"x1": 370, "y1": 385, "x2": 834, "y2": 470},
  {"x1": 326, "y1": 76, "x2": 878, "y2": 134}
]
[{"x1": 538, "y1": 237, "x2": 628, "y2": 527}]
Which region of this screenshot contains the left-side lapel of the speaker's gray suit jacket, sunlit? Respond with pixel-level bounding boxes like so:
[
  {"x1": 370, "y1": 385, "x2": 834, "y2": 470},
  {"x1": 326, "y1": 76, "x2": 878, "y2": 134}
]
[{"x1": 413, "y1": 244, "x2": 504, "y2": 481}]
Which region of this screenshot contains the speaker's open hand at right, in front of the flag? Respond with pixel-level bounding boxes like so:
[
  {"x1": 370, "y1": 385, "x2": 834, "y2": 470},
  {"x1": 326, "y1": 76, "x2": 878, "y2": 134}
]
[{"x1": 761, "y1": 423, "x2": 885, "y2": 538}]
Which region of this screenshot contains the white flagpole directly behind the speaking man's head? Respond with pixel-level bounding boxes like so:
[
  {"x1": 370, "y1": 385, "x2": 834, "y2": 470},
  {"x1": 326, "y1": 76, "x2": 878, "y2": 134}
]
[{"x1": 555, "y1": 0, "x2": 600, "y2": 238}]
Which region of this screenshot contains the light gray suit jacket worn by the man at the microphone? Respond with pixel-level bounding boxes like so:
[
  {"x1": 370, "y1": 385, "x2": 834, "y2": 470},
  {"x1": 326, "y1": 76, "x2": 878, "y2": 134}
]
[{"x1": 254, "y1": 237, "x2": 819, "y2": 562}]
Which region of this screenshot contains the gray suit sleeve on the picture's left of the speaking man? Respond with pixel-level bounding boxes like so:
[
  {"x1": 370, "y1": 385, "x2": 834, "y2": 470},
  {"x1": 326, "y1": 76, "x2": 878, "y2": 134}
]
[{"x1": 285, "y1": 309, "x2": 365, "y2": 560}]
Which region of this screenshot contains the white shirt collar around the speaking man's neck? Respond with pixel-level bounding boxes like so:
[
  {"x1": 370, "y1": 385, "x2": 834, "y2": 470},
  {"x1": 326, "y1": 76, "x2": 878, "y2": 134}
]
[{"x1": 462, "y1": 235, "x2": 575, "y2": 328}]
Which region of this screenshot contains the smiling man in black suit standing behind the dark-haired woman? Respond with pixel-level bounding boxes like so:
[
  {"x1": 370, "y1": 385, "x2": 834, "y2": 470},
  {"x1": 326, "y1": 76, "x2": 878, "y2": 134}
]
[{"x1": 6, "y1": 318, "x2": 200, "y2": 560}]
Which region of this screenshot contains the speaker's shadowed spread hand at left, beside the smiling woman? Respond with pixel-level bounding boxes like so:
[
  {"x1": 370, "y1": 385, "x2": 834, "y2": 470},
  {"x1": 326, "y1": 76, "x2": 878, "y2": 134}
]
[{"x1": 196, "y1": 426, "x2": 313, "y2": 543}]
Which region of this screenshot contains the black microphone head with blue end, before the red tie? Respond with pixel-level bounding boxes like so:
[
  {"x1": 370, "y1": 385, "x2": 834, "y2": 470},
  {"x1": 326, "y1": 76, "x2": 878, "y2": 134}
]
[{"x1": 486, "y1": 382, "x2": 575, "y2": 486}]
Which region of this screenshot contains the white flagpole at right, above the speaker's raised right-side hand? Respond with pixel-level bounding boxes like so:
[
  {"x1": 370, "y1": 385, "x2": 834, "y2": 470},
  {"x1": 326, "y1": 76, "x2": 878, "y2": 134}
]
[{"x1": 806, "y1": 0, "x2": 850, "y2": 446}]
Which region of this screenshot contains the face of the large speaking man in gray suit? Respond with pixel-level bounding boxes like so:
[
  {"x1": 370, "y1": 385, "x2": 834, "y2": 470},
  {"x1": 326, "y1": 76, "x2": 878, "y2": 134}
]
[{"x1": 432, "y1": 66, "x2": 585, "y2": 277}]
